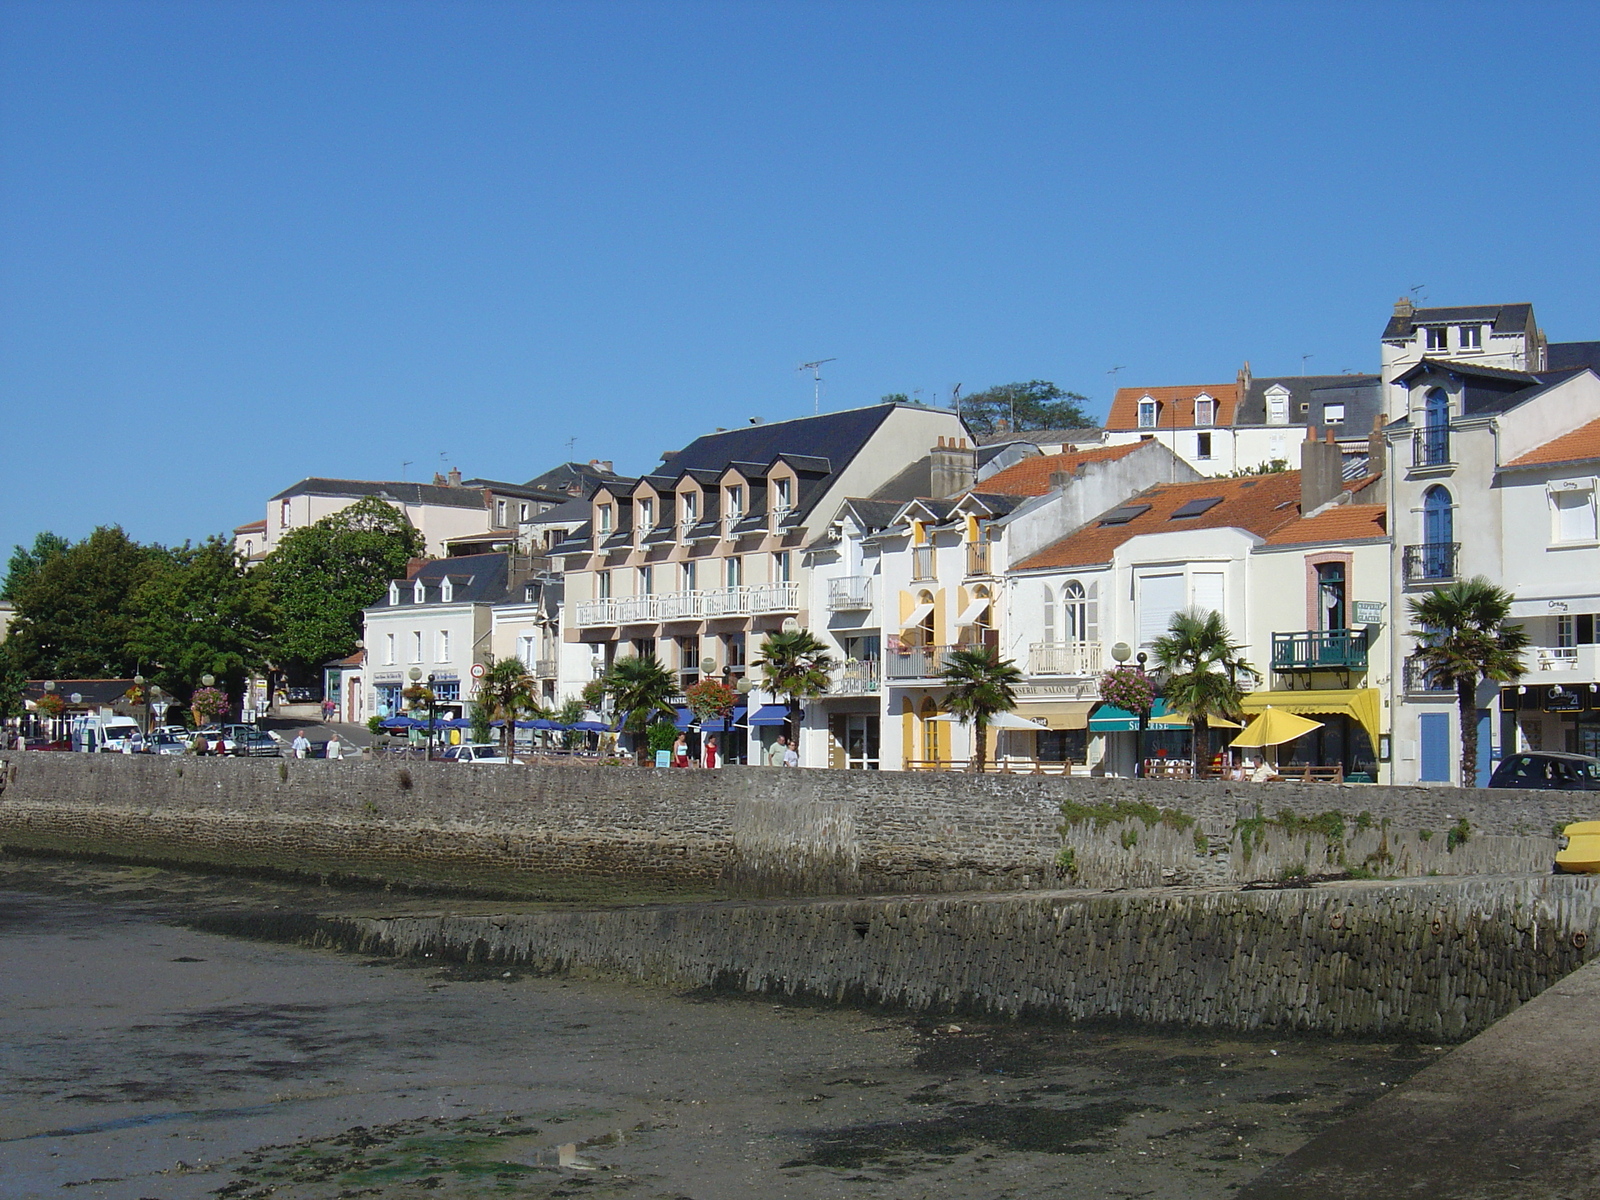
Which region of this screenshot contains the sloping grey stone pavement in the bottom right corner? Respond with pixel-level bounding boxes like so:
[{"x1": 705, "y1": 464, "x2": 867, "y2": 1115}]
[{"x1": 1238, "y1": 963, "x2": 1600, "y2": 1200}]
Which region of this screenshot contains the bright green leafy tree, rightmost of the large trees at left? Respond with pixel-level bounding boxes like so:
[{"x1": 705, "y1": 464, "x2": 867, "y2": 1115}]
[{"x1": 262, "y1": 496, "x2": 426, "y2": 672}]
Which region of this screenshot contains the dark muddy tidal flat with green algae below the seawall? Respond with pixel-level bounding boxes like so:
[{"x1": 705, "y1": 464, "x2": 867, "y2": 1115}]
[{"x1": 0, "y1": 856, "x2": 1443, "y2": 1200}]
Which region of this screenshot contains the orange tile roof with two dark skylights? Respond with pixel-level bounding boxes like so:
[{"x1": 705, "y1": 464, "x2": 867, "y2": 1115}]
[{"x1": 1018, "y1": 470, "x2": 1301, "y2": 571}]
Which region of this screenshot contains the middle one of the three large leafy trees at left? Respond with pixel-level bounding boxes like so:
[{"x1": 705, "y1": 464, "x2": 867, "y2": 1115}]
[{"x1": 128, "y1": 536, "x2": 272, "y2": 702}]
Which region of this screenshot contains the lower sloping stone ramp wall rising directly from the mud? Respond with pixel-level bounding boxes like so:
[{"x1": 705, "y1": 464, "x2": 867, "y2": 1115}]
[{"x1": 236, "y1": 877, "x2": 1600, "y2": 1040}]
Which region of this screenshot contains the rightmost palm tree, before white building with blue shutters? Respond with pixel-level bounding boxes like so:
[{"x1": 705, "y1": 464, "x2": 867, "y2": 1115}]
[{"x1": 1406, "y1": 574, "x2": 1528, "y2": 786}]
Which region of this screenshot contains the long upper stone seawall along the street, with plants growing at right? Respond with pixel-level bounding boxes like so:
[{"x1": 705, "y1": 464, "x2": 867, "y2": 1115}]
[{"x1": 0, "y1": 754, "x2": 1594, "y2": 898}]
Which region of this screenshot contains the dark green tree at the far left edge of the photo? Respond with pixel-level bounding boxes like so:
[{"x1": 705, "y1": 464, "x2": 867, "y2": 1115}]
[{"x1": 8, "y1": 525, "x2": 170, "y2": 678}]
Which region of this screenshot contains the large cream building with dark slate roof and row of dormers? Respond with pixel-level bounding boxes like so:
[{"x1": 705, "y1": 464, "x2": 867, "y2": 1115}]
[{"x1": 552, "y1": 403, "x2": 970, "y2": 754}]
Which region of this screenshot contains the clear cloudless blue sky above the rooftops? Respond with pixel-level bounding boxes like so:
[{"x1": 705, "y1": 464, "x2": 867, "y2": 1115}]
[{"x1": 0, "y1": 0, "x2": 1600, "y2": 554}]
